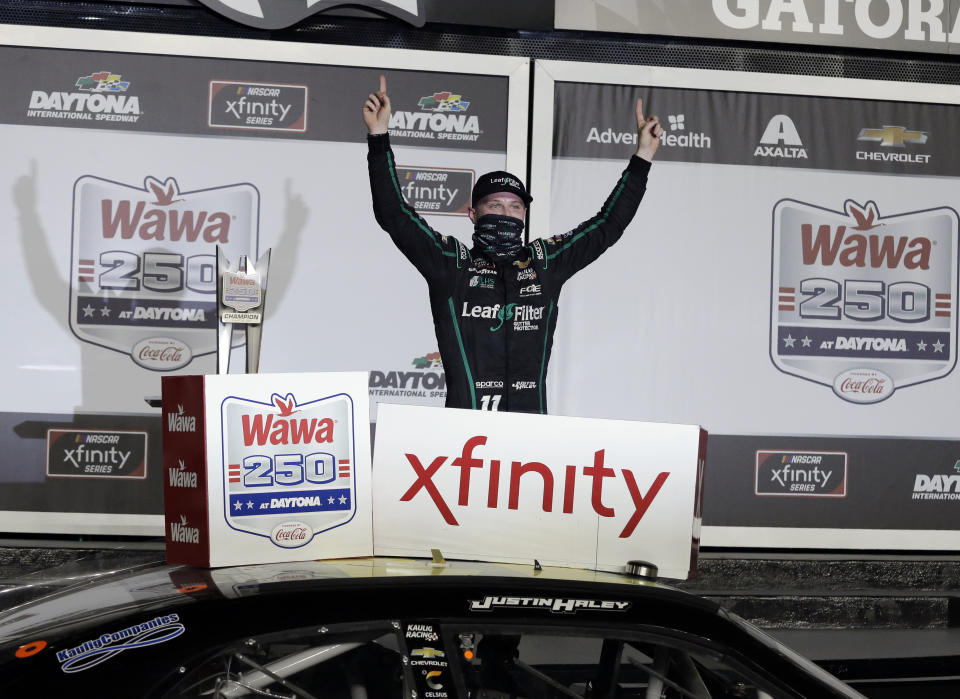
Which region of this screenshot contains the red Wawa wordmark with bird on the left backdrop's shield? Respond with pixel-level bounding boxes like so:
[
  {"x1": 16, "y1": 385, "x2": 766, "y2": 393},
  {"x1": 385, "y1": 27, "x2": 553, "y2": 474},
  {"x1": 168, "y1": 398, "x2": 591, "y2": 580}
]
[{"x1": 100, "y1": 176, "x2": 231, "y2": 245}]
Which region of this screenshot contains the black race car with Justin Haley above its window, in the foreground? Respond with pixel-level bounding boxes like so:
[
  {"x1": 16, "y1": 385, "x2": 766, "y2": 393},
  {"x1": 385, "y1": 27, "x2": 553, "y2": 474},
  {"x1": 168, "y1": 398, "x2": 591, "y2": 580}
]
[{"x1": 0, "y1": 556, "x2": 862, "y2": 699}]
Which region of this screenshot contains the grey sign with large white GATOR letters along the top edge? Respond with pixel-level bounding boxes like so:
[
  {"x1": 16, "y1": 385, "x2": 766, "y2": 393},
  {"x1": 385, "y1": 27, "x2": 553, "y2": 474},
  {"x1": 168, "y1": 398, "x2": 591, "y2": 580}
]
[{"x1": 555, "y1": 0, "x2": 960, "y2": 53}]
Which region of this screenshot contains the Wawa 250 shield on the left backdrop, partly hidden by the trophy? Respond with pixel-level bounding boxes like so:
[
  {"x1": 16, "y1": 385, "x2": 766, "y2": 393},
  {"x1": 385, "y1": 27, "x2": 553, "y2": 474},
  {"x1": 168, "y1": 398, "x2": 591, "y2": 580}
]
[{"x1": 70, "y1": 175, "x2": 260, "y2": 371}]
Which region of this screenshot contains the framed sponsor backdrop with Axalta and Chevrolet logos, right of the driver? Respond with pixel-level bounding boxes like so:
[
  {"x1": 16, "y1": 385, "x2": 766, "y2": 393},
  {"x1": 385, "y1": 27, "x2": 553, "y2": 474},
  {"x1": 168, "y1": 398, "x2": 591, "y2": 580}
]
[{"x1": 531, "y1": 62, "x2": 960, "y2": 549}]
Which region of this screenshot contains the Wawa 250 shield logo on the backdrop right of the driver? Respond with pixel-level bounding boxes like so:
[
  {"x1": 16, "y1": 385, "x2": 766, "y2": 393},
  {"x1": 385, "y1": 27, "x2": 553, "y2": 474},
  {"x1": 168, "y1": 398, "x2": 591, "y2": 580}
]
[{"x1": 770, "y1": 199, "x2": 958, "y2": 403}]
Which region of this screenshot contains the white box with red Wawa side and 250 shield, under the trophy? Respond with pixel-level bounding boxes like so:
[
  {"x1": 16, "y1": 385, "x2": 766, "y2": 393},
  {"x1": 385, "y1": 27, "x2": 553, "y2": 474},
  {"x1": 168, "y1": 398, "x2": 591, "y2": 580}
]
[{"x1": 163, "y1": 373, "x2": 372, "y2": 566}]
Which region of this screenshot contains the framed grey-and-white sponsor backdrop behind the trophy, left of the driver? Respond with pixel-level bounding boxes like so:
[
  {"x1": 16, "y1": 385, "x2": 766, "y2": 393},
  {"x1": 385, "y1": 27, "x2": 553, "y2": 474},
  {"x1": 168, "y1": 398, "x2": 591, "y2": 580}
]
[{"x1": 0, "y1": 27, "x2": 529, "y2": 534}]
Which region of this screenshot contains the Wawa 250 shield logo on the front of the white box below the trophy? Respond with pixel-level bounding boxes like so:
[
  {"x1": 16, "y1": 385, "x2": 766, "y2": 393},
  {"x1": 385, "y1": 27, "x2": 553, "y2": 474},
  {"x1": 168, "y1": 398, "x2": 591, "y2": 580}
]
[{"x1": 221, "y1": 393, "x2": 357, "y2": 548}]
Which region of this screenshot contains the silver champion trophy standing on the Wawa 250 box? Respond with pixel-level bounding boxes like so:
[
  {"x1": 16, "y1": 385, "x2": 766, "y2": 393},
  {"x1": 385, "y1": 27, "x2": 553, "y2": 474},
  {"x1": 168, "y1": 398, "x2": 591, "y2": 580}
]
[{"x1": 217, "y1": 245, "x2": 270, "y2": 374}]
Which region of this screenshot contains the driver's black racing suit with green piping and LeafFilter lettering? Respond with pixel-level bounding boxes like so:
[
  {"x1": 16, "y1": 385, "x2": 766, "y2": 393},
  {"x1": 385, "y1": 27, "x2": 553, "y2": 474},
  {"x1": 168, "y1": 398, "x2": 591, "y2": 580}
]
[{"x1": 367, "y1": 134, "x2": 650, "y2": 413}]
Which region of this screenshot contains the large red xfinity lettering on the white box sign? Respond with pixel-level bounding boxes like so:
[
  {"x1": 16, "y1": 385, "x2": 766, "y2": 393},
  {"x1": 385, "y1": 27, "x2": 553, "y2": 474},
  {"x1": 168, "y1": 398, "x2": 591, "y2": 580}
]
[{"x1": 400, "y1": 435, "x2": 670, "y2": 539}]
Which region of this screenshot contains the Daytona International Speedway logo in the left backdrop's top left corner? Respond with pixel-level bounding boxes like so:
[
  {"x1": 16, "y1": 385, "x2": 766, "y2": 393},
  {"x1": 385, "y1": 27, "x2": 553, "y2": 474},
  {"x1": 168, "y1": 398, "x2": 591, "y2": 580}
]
[{"x1": 27, "y1": 71, "x2": 141, "y2": 123}]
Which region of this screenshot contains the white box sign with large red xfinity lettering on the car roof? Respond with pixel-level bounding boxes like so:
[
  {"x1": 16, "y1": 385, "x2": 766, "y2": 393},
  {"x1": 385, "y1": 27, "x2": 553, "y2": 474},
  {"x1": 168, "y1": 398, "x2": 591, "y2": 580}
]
[{"x1": 373, "y1": 404, "x2": 706, "y2": 578}]
